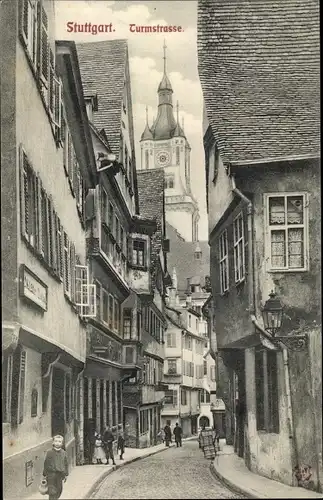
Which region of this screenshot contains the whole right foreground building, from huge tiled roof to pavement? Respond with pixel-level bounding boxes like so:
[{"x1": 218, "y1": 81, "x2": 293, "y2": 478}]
[{"x1": 198, "y1": 1, "x2": 322, "y2": 491}]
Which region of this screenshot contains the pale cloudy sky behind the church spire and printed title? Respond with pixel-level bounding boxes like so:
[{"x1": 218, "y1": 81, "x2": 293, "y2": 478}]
[{"x1": 55, "y1": 0, "x2": 207, "y2": 240}]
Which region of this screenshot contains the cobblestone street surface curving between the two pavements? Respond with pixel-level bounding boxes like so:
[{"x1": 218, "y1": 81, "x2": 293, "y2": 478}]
[{"x1": 92, "y1": 441, "x2": 247, "y2": 500}]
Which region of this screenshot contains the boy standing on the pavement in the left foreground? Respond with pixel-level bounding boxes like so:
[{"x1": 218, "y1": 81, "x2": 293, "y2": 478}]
[{"x1": 43, "y1": 435, "x2": 68, "y2": 500}]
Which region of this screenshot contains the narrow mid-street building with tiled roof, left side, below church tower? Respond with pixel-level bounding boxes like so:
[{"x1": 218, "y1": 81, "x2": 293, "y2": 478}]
[{"x1": 124, "y1": 169, "x2": 167, "y2": 448}]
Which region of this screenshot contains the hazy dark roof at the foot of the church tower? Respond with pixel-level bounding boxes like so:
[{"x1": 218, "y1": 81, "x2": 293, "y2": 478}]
[{"x1": 166, "y1": 223, "x2": 210, "y2": 296}]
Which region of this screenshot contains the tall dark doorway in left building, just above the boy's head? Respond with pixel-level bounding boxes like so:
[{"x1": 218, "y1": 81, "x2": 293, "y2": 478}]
[{"x1": 52, "y1": 368, "x2": 65, "y2": 438}]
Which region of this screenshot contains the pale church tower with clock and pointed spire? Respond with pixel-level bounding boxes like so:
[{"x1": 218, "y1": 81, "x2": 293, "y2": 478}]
[{"x1": 140, "y1": 44, "x2": 199, "y2": 241}]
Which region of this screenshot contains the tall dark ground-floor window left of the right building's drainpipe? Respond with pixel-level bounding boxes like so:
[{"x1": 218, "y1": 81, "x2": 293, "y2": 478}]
[{"x1": 255, "y1": 349, "x2": 279, "y2": 433}]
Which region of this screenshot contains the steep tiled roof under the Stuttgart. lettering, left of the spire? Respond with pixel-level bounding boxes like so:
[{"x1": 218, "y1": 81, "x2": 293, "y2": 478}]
[{"x1": 76, "y1": 40, "x2": 128, "y2": 154}]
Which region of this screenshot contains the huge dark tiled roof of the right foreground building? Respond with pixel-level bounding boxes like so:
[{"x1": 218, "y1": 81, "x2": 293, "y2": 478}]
[{"x1": 198, "y1": 0, "x2": 320, "y2": 161}]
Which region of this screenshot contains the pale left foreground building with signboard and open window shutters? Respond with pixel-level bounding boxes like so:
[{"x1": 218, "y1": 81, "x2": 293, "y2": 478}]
[{"x1": 0, "y1": 1, "x2": 96, "y2": 498}]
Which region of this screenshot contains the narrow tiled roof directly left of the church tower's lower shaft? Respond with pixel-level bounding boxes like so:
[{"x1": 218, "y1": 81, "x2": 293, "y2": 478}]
[{"x1": 137, "y1": 168, "x2": 165, "y2": 285}]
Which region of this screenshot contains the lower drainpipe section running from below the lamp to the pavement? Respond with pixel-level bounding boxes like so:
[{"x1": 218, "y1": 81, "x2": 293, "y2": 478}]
[{"x1": 251, "y1": 315, "x2": 298, "y2": 486}]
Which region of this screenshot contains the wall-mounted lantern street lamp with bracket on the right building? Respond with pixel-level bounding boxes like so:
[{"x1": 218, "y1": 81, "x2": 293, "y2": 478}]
[{"x1": 262, "y1": 290, "x2": 308, "y2": 351}]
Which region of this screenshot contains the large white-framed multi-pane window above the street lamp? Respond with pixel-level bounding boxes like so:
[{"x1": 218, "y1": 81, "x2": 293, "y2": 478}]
[{"x1": 265, "y1": 193, "x2": 308, "y2": 271}]
